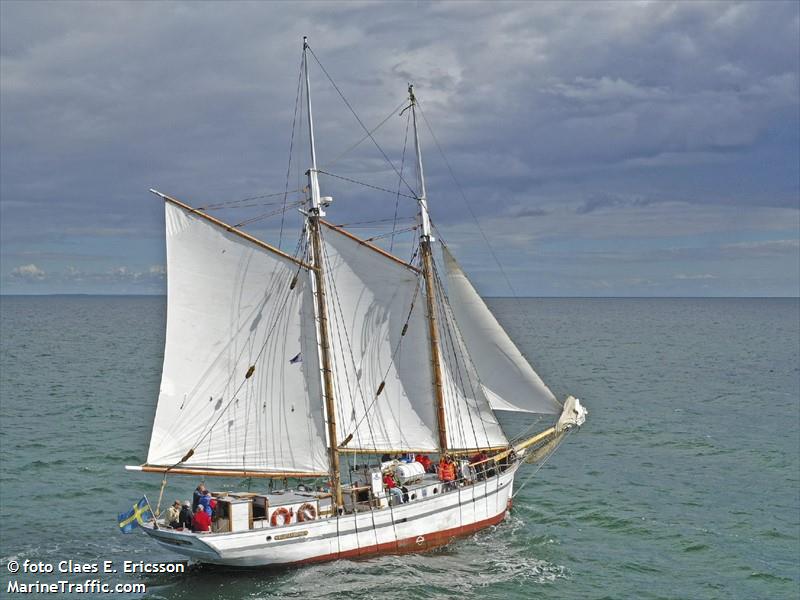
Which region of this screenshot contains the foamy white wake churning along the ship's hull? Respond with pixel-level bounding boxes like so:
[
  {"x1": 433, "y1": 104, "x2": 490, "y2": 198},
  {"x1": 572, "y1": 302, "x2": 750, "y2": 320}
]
[{"x1": 150, "y1": 515, "x2": 568, "y2": 600}]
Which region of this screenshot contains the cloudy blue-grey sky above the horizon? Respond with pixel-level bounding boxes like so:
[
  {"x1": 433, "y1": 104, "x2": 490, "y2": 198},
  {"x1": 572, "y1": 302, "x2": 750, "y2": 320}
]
[{"x1": 0, "y1": 1, "x2": 800, "y2": 296}]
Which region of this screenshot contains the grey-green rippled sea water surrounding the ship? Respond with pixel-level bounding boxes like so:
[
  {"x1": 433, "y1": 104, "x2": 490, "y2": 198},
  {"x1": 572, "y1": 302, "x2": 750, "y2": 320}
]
[{"x1": 0, "y1": 296, "x2": 800, "y2": 600}]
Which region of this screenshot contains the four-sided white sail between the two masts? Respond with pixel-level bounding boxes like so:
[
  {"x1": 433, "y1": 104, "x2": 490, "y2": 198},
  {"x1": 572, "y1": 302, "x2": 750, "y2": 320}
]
[{"x1": 322, "y1": 226, "x2": 438, "y2": 452}]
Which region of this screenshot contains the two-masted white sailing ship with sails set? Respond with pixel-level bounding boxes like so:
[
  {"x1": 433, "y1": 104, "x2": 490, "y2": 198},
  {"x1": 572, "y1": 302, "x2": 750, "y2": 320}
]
[{"x1": 126, "y1": 38, "x2": 586, "y2": 567}]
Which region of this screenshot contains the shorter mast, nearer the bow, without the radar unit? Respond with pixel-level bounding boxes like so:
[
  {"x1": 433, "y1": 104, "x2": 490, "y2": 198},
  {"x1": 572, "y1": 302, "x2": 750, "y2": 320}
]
[{"x1": 408, "y1": 84, "x2": 447, "y2": 452}]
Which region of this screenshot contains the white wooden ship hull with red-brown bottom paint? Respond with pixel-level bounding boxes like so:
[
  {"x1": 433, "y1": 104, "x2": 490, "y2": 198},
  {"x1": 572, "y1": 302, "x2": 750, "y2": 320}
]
[{"x1": 144, "y1": 464, "x2": 518, "y2": 567}]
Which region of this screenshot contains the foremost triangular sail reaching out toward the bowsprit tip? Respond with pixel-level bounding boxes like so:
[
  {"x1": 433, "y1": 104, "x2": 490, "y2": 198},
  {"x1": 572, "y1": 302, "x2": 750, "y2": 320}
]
[{"x1": 443, "y1": 247, "x2": 561, "y2": 414}]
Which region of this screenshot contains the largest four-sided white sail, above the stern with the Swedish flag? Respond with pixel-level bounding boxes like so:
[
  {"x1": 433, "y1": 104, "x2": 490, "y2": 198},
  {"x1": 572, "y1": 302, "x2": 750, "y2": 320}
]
[{"x1": 147, "y1": 203, "x2": 328, "y2": 473}]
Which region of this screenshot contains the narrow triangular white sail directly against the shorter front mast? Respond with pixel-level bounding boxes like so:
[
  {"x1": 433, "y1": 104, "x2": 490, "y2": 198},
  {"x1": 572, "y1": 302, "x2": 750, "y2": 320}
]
[{"x1": 438, "y1": 286, "x2": 508, "y2": 450}]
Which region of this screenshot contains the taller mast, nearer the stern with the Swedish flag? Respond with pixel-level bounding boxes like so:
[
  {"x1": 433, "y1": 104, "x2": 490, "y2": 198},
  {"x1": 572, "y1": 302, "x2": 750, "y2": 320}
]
[{"x1": 303, "y1": 36, "x2": 342, "y2": 513}]
